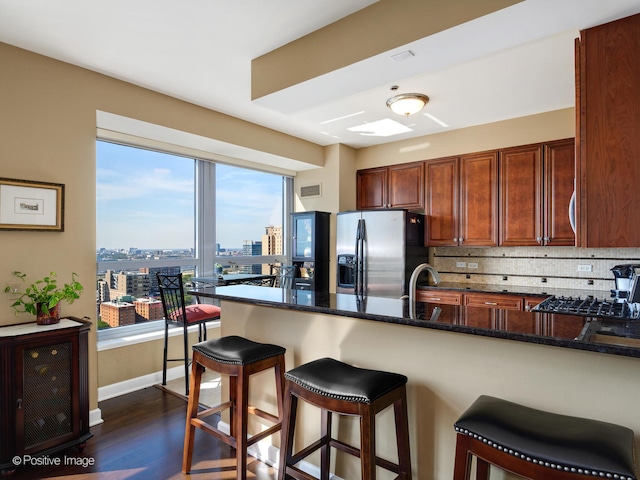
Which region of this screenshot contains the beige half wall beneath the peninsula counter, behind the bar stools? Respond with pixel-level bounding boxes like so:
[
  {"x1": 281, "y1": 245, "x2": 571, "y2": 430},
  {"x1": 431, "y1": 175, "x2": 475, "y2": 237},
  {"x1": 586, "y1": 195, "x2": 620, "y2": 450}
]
[{"x1": 222, "y1": 301, "x2": 640, "y2": 480}]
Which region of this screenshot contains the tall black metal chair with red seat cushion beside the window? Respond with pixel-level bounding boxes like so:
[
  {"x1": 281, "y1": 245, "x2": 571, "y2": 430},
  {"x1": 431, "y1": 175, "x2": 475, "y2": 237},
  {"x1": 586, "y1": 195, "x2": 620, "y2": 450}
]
[{"x1": 156, "y1": 273, "x2": 220, "y2": 396}]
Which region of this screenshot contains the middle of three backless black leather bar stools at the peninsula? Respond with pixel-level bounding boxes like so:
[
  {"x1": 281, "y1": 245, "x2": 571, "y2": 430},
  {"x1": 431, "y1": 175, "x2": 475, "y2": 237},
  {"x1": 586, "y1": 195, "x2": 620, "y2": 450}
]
[{"x1": 278, "y1": 358, "x2": 411, "y2": 480}]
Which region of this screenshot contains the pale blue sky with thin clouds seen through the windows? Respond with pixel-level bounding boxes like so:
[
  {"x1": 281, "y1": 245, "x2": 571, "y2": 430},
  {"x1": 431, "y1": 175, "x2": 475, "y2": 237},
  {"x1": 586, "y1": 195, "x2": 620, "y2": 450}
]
[{"x1": 96, "y1": 141, "x2": 282, "y2": 249}]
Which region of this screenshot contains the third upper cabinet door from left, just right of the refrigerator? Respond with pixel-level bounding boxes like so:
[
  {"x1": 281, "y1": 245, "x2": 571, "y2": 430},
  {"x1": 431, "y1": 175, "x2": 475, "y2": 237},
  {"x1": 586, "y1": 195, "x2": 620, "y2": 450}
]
[{"x1": 425, "y1": 157, "x2": 459, "y2": 247}]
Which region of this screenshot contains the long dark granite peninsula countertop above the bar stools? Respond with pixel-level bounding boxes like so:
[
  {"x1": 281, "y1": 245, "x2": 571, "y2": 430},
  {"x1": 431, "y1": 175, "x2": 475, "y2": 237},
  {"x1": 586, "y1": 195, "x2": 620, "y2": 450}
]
[{"x1": 189, "y1": 285, "x2": 640, "y2": 358}]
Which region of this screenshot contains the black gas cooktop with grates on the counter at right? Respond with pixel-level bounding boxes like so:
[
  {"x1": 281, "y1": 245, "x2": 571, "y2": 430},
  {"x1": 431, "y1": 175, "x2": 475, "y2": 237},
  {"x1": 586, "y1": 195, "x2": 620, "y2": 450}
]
[{"x1": 532, "y1": 295, "x2": 637, "y2": 319}]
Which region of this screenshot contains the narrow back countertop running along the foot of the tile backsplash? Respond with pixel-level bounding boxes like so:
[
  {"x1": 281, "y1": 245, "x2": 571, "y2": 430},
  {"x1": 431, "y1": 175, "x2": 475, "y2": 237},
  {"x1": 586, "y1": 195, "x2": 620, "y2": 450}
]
[{"x1": 417, "y1": 282, "x2": 611, "y2": 298}]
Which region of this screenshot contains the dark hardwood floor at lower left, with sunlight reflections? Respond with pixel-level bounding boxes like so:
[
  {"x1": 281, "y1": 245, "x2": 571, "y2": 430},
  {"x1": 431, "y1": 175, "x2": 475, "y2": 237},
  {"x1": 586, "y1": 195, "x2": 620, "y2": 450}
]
[{"x1": 7, "y1": 387, "x2": 276, "y2": 480}]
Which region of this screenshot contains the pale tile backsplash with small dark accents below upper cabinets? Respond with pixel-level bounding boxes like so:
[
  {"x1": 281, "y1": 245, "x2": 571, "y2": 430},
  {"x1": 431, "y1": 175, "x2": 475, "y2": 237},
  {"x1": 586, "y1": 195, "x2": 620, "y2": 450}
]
[{"x1": 429, "y1": 247, "x2": 640, "y2": 291}]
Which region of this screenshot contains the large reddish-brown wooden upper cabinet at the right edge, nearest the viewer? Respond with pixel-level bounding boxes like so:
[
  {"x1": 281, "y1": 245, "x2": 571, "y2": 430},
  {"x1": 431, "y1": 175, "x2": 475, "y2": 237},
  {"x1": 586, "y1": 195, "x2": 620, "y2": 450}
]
[{"x1": 576, "y1": 14, "x2": 640, "y2": 247}]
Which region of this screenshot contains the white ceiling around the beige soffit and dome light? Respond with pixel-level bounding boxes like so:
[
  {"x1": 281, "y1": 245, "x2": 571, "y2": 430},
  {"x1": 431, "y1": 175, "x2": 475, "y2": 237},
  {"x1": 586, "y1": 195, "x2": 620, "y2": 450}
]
[{"x1": 0, "y1": 0, "x2": 640, "y2": 156}]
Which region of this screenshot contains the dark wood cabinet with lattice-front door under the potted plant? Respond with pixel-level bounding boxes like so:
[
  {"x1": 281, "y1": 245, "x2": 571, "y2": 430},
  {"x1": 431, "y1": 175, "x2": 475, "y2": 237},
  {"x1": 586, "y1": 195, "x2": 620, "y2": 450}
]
[{"x1": 0, "y1": 319, "x2": 91, "y2": 474}]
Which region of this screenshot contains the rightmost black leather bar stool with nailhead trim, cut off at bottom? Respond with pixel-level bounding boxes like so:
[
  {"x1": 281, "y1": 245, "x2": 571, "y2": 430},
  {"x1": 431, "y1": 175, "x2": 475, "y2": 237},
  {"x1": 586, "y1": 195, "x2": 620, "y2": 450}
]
[{"x1": 453, "y1": 395, "x2": 637, "y2": 480}]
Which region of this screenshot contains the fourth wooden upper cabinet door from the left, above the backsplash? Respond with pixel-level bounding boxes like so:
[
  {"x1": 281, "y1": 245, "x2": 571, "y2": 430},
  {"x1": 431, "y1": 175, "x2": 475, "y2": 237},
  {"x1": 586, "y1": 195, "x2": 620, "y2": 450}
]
[{"x1": 458, "y1": 152, "x2": 498, "y2": 247}]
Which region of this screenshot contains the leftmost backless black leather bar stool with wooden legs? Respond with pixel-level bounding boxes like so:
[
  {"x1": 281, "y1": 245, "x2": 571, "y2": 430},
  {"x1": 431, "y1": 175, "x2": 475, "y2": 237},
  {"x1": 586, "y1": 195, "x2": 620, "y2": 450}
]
[{"x1": 182, "y1": 336, "x2": 285, "y2": 480}]
